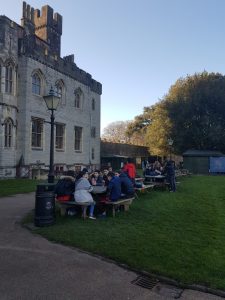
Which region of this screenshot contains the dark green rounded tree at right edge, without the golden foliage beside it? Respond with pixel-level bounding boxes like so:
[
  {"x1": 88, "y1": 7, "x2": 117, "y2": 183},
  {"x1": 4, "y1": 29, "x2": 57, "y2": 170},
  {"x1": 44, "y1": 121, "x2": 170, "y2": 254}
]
[{"x1": 164, "y1": 72, "x2": 225, "y2": 154}]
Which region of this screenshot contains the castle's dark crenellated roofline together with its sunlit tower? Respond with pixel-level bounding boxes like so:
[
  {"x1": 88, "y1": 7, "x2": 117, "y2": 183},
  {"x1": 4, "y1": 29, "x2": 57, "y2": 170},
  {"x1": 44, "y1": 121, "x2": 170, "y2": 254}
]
[{"x1": 19, "y1": 2, "x2": 102, "y2": 95}]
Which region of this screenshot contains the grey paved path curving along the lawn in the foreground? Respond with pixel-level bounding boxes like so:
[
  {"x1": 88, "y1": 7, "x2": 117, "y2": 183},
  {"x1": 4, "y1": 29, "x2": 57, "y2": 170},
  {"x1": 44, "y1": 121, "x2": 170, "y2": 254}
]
[{"x1": 0, "y1": 193, "x2": 222, "y2": 300}]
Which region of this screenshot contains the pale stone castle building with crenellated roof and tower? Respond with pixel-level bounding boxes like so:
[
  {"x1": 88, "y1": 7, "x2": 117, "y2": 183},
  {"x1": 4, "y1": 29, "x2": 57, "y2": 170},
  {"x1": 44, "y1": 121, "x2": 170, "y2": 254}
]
[{"x1": 0, "y1": 2, "x2": 102, "y2": 178}]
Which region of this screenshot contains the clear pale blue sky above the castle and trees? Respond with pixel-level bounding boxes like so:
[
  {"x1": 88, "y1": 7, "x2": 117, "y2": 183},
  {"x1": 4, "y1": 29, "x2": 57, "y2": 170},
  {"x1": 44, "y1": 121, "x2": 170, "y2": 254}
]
[{"x1": 0, "y1": 0, "x2": 225, "y2": 130}]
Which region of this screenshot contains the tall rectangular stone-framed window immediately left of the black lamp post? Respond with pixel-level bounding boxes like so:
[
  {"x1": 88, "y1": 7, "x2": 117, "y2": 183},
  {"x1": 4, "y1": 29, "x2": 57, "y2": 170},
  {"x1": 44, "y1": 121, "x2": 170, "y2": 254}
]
[{"x1": 31, "y1": 118, "x2": 44, "y2": 149}]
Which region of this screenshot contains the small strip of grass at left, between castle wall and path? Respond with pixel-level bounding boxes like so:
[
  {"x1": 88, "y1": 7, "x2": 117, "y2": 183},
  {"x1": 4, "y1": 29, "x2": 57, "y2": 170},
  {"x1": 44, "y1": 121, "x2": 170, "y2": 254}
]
[{"x1": 0, "y1": 179, "x2": 43, "y2": 197}]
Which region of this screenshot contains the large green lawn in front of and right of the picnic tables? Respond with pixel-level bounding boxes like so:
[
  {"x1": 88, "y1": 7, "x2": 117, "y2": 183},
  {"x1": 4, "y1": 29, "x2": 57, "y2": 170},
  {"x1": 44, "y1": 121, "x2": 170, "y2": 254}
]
[{"x1": 3, "y1": 176, "x2": 225, "y2": 290}]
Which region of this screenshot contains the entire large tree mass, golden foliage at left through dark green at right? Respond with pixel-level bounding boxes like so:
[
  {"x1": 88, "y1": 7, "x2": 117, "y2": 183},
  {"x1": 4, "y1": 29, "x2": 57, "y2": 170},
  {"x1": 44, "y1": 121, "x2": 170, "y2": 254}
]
[{"x1": 128, "y1": 71, "x2": 225, "y2": 155}]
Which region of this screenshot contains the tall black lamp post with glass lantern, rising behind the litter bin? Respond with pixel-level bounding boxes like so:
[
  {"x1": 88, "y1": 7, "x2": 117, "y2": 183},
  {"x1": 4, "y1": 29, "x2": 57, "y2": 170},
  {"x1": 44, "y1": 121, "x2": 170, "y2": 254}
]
[{"x1": 43, "y1": 87, "x2": 60, "y2": 183}]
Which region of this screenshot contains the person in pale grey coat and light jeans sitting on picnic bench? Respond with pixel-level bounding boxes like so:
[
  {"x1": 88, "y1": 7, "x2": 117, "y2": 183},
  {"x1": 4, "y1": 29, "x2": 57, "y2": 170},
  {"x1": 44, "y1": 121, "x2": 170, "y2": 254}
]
[{"x1": 74, "y1": 171, "x2": 96, "y2": 219}]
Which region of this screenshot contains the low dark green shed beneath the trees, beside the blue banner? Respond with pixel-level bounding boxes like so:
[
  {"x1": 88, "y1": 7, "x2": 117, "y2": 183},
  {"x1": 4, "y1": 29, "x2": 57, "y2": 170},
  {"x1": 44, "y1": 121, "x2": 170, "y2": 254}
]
[{"x1": 183, "y1": 150, "x2": 223, "y2": 174}]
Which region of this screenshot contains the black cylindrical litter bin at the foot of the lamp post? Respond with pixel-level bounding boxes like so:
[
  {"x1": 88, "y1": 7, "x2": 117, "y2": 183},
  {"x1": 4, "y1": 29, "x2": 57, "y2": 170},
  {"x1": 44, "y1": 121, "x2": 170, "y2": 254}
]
[{"x1": 34, "y1": 183, "x2": 55, "y2": 226}]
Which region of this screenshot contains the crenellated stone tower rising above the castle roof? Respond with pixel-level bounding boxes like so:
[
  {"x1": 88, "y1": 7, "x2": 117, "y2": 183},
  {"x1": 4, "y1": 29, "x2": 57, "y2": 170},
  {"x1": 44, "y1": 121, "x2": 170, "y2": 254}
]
[{"x1": 21, "y1": 2, "x2": 62, "y2": 56}]
